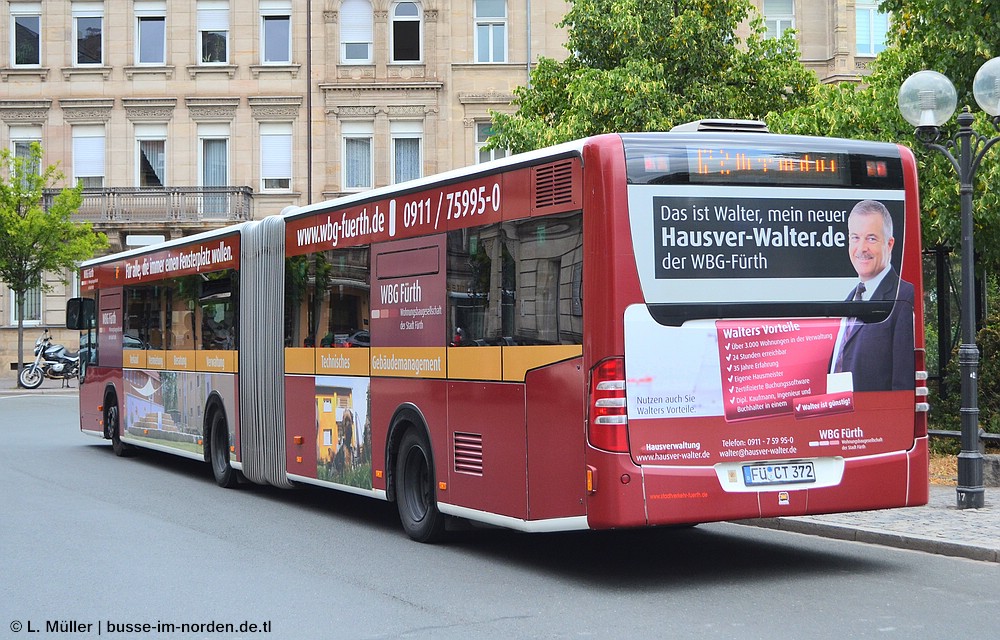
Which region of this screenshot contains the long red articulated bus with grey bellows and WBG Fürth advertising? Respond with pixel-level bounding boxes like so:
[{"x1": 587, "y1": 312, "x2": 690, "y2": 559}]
[{"x1": 67, "y1": 123, "x2": 928, "y2": 541}]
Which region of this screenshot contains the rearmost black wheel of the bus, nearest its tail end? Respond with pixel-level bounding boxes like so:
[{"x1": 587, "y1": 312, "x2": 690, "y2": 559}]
[{"x1": 396, "y1": 429, "x2": 444, "y2": 542}]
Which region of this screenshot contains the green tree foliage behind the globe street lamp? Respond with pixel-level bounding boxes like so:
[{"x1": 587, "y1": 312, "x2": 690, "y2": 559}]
[{"x1": 766, "y1": 0, "x2": 1000, "y2": 271}]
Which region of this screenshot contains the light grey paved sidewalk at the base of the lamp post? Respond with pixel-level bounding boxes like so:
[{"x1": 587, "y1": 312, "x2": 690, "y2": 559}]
[{"x1": 738, "y1": 485, "x2": 1000, "y2": 562}]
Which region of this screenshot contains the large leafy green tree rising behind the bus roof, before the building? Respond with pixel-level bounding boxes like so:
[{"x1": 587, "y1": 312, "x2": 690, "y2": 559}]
[{"x1": 490, "y1": 0, "x2": 817, "y2": 152}]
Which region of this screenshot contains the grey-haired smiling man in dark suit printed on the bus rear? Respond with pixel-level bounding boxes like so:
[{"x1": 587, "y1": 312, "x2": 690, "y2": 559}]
[{"x1": 830, "y1": 200, "x2": 915, "y2": 391}]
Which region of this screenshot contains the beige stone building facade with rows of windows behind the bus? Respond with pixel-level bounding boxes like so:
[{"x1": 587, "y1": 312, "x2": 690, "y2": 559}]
[{"x1": 0, "y1": 0, "x2": 892, "y2": 379}]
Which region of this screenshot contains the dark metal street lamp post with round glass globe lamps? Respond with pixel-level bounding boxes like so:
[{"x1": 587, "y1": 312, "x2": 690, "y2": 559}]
[{"x1": 899, "y1": 58, "x2": 1000, "y2": 509}]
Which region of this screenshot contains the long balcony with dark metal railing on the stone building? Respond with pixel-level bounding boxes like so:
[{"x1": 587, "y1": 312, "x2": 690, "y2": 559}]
[{"x1": 44, "y1": 186, "x2": 253, "y2": 227}]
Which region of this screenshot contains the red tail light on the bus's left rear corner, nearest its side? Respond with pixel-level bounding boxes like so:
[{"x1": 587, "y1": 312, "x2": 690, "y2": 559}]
[{"x1": 588, "y1": 358, "x2": 628, "y2": 453}]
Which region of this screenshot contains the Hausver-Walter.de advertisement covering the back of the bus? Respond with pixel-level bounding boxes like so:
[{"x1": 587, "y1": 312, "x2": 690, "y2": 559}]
[{"x1": 625, "y1": 187, "x2": 915, "y2": 464}]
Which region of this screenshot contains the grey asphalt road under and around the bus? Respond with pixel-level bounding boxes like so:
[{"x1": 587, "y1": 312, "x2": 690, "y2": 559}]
[{"x1": 0, "y1": 395, "x2": 1000, "y2": 640}]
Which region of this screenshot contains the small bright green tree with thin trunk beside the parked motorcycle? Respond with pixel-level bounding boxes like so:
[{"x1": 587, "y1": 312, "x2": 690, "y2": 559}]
[{"x1": 0, "y1": 143, "x2": 108, "y2": 384}]
